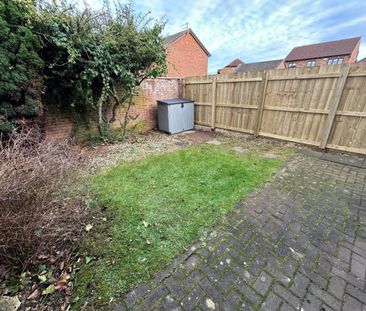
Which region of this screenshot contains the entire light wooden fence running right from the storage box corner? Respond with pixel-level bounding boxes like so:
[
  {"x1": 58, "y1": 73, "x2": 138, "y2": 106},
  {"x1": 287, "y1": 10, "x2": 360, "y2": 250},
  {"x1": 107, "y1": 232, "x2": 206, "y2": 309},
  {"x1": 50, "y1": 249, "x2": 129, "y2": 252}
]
[{"x1": 185, "y1": 63, "x2": 366, "y2": 154}]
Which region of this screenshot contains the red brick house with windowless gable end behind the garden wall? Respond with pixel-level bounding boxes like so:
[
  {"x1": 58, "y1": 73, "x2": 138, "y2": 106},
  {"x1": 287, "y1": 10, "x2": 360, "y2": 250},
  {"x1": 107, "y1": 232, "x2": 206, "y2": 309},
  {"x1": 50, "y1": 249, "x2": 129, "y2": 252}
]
[{"x1": 165, "y1": 28, "x2": 211, "y2": 77}]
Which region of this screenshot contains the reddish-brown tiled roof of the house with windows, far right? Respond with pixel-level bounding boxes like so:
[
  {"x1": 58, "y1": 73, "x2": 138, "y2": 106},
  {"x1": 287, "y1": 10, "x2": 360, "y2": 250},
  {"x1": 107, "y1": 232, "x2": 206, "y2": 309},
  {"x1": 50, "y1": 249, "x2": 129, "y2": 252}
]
[{"x1": 285, "y1": 37, "x2": 361, "y2": 61}]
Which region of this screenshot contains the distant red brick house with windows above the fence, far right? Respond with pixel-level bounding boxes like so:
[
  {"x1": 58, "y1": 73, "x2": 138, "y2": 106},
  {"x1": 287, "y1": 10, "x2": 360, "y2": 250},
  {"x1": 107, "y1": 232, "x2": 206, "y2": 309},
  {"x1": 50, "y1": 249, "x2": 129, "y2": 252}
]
[{"x1": 280, "y1": 37, "x2": 361, "y2": 68}]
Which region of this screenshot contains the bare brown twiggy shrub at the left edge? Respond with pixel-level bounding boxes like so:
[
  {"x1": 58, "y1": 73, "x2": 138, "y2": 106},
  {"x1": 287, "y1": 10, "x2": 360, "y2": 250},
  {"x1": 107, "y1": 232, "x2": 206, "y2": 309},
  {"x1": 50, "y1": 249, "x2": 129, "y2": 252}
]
[{"x1": 0, "y1": 130, "x2": 80, "y2": 268}]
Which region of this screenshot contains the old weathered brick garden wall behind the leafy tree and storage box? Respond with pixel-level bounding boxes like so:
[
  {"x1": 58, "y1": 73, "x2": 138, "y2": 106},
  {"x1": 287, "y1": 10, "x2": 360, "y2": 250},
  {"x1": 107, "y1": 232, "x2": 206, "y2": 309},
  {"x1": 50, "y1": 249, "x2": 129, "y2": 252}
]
[{"x1": 44, "y1": 78, "x2": 183, "y2": 139}]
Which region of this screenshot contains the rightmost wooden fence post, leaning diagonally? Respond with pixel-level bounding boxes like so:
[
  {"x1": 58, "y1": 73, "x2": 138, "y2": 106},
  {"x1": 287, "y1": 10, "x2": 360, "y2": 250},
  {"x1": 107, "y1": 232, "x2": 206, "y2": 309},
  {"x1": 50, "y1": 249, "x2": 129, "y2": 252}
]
[{"x1": 319, "y1": 64, "x2": 350, "y2": 149}]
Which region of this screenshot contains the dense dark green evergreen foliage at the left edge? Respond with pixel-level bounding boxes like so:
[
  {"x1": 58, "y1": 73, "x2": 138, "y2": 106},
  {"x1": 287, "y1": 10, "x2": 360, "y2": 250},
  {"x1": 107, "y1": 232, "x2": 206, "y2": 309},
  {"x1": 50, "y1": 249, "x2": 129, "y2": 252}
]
[{"x1": 0, "y1": 0, "x2": 42, "y2": 133}]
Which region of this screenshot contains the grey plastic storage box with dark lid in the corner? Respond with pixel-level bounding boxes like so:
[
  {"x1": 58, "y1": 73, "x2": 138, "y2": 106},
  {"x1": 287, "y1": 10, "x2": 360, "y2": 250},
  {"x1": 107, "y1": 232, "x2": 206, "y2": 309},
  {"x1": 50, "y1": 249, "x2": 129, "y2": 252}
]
[{"x1": 158, "y1": 98, "x2": 194, "y2": 134}]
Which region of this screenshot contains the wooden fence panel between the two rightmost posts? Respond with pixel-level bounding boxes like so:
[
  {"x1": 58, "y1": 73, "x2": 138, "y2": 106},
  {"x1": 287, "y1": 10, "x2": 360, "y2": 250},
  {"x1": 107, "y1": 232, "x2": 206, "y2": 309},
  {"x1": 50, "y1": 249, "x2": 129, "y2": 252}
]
[{"x1": 259, "y1": 66, "x2": 339, "y2": 145}]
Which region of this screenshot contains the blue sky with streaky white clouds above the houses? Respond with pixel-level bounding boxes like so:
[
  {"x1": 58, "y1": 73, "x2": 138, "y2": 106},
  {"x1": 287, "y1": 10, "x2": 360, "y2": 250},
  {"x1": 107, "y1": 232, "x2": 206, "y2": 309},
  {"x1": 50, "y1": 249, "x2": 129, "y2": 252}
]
[{"x1": 84, "y1": 0, "x2": 366, "y2": 73}]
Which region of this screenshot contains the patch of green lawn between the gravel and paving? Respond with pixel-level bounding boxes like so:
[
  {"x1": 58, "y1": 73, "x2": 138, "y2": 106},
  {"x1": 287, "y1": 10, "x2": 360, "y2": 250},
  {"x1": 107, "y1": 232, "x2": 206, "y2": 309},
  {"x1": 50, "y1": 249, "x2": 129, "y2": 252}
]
[{"x1": 74, "y1": 145, "x2": 283, "y2": 303}]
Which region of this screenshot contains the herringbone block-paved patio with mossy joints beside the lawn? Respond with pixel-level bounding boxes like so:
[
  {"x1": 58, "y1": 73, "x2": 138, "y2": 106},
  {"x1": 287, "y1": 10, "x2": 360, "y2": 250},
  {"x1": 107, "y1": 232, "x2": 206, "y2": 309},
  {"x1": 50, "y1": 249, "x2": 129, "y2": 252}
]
[{"x1": 114, "y1": 155, "x2": 366, "y2": 311}]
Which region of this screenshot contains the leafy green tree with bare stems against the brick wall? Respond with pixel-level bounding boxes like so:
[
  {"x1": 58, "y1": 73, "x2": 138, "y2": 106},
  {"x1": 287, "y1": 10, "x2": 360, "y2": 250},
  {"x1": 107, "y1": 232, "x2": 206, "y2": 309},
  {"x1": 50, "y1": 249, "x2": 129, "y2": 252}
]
[{"x1": 38, "y1": 1, "x2": 166, "y2": 136}]
